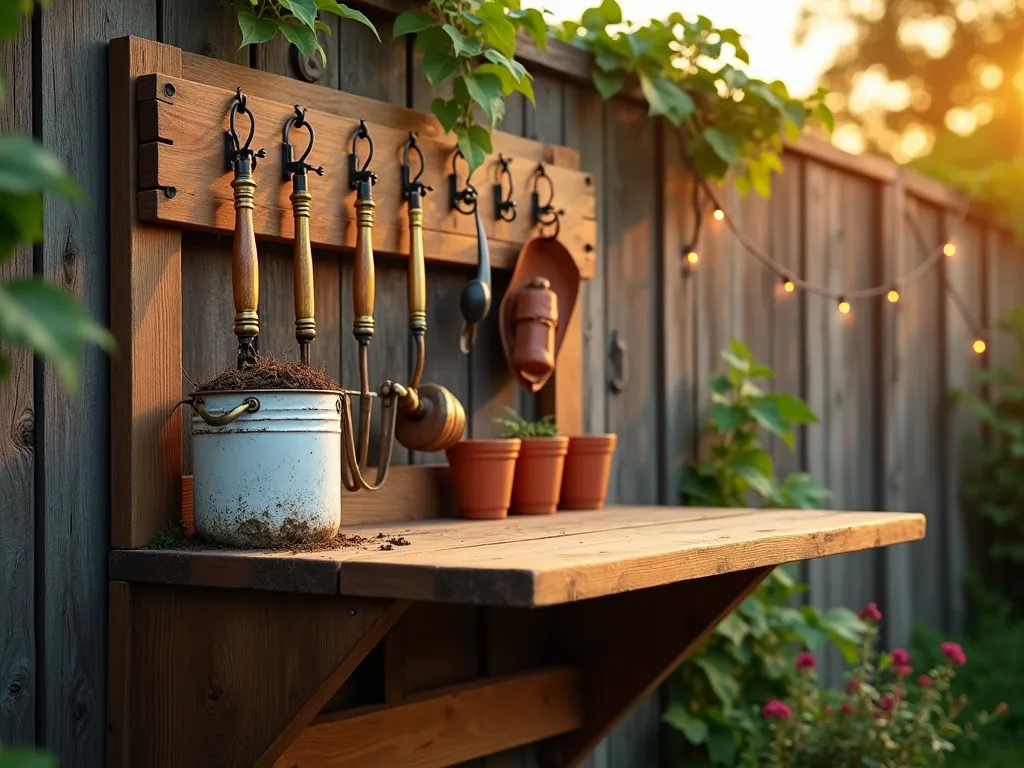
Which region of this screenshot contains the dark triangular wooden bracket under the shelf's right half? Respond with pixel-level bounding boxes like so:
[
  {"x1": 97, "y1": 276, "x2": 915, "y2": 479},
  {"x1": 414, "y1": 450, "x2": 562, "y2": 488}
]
[{"x1": 543, "y1": 567, "x2": 771, "y2": 768}]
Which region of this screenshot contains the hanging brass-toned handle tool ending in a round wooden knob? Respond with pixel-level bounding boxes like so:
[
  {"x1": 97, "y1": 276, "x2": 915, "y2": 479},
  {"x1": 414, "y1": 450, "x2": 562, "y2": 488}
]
[{"x1": 394, "y1": 133, "x2": 466, "y2": 452}]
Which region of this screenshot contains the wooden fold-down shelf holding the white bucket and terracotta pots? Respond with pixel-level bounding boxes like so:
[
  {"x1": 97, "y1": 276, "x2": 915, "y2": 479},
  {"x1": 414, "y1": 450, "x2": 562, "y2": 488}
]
[{"x1": 111, "y1": 507, "x2": 925, "y2": 606}]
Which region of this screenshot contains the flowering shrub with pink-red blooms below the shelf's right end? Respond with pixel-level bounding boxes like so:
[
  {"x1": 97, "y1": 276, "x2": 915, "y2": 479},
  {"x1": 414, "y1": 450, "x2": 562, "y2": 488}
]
[{"x1": 743, "y1": 603, "x2": 1007, "y2": 768}]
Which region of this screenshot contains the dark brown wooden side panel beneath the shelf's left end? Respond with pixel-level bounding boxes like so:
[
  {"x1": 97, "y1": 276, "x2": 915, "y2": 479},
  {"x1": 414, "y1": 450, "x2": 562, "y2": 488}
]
[{"x1": 108, "y1": 582, "x2": 409, "y2": 768}]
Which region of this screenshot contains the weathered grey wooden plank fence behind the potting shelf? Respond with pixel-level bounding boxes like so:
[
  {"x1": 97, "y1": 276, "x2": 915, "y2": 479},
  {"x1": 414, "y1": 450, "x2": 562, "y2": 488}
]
[{"x1": 0, "y1": 0, "x2": 1024, "y2": 768}]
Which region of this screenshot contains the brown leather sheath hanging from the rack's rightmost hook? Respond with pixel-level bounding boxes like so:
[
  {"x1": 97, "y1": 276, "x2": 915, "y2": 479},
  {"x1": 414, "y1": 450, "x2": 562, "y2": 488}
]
[{"x1": 499, "y1": 237, "x2": 580, "y2": 392}]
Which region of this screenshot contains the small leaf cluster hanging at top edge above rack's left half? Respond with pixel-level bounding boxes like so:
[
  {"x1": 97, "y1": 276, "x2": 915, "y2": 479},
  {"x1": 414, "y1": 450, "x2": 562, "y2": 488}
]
[{"x1": 234, "y1": 0, "x2": 381, "y2": 65}]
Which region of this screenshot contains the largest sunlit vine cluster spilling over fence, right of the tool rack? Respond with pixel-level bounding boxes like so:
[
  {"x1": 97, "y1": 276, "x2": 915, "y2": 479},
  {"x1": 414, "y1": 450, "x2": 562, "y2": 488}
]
[{"x1": 555, "y1": 0, "x2": 833, "y2": 197}]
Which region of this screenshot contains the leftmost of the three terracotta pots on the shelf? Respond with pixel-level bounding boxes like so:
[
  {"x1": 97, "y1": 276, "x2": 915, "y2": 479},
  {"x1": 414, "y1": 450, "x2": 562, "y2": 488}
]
[{"x1": 445, "y1": 438, "x2": 522, "y2": 520}]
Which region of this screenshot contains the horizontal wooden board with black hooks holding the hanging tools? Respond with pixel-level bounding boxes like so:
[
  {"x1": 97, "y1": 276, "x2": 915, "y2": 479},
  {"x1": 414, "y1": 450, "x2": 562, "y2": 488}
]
[{"x1": 137, "y1": 74, "x2": 597, "y2": 276}]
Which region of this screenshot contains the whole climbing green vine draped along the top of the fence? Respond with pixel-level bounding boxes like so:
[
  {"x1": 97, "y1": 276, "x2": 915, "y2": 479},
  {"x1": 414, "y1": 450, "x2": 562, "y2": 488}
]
[{"x1": 237, "y1": 0, "x2": 833, "y2": 197}]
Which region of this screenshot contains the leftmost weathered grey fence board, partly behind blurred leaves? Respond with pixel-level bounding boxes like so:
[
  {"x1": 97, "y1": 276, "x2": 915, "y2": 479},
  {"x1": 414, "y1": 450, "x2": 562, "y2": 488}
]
[{"x1": 0, "y1": 18, "x2": 37, "y2": 744}]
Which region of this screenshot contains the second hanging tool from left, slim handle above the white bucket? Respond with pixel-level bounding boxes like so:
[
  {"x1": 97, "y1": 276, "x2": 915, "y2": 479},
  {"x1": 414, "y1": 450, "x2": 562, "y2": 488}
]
[{"x1": 281, "y1": 104, "x2": 324, "y2": 366}]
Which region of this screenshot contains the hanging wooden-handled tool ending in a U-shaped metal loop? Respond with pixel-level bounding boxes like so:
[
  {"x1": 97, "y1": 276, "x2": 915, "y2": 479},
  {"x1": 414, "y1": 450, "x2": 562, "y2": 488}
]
[{"x1": 341, "y1": 120, "x2": 401, "y2": 490}]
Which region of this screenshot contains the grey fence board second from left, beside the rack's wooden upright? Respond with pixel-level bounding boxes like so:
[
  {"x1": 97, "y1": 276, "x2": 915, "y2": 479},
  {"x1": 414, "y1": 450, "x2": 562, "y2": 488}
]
[{"x1": 36, "y1": 0, "x2": 157, "y2": 766}]
